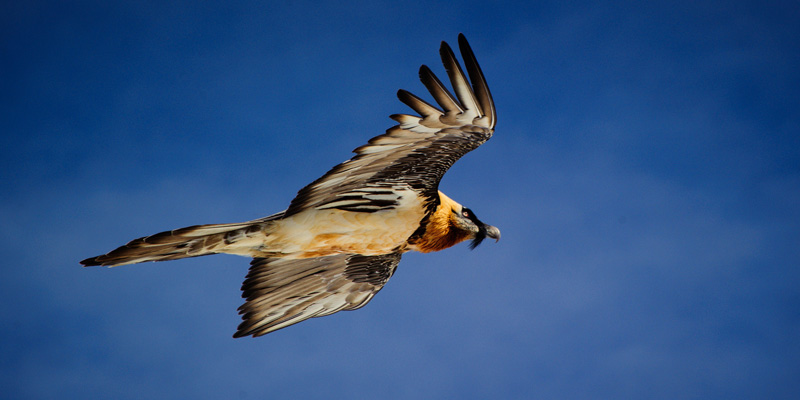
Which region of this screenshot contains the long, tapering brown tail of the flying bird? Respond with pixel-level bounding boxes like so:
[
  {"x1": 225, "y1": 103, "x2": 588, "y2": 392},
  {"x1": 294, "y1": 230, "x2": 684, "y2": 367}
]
[{"x1": 81, "y1": 217, "x2": 270, "y2": 267}]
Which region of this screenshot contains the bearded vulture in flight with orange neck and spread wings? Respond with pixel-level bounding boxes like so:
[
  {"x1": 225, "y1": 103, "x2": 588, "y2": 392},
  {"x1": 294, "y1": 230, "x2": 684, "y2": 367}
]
[{"x1": 80, "y1": 34, "x2": 500, "y2": 338}]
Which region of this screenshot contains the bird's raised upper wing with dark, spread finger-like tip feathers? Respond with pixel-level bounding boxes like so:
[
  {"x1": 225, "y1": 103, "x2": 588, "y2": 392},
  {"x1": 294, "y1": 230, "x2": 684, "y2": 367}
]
[{"x1": 286, "y1": 34, "x2": 496, "y2": 216}]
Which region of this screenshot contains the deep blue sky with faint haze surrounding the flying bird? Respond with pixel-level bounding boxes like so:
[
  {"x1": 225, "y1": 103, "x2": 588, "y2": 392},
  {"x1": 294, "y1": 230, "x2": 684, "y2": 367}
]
[{"x1": 0, "y1": 0, "x2": 800, "y2": 399}]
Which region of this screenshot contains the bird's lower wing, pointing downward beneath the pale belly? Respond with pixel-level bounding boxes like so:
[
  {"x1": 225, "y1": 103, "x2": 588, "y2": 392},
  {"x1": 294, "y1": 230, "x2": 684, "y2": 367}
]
[{"x1": 233, "y1": 253, "x2": 400, "y2": 337}]
